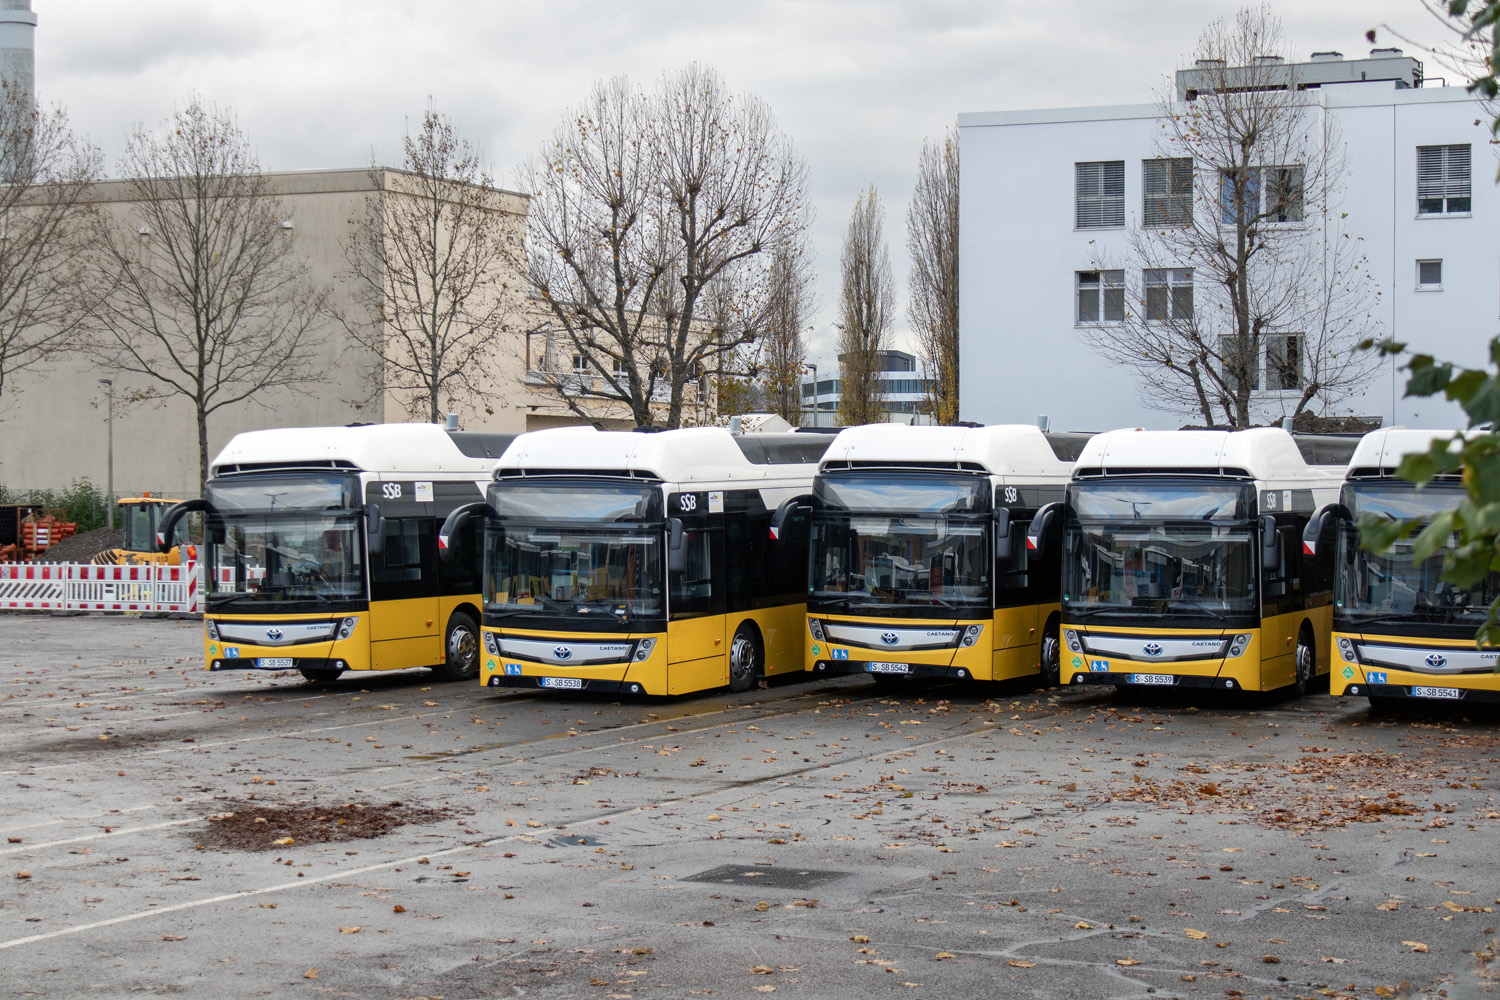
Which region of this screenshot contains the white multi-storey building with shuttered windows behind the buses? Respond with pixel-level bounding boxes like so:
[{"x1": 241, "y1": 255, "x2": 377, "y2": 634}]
[{"x1": 959, "y1": 49, "x2": 1500, "y2": 430}]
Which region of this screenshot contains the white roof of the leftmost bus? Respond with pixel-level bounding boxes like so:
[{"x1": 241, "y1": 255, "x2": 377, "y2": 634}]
[{"x1": 210, "y1": 423, "x2": 516, "y2": 478}]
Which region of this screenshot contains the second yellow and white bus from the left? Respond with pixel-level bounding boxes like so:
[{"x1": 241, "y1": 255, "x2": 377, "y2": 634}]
[{"x1": 443, "y1": 427, "x2": 830, "y2": 694}]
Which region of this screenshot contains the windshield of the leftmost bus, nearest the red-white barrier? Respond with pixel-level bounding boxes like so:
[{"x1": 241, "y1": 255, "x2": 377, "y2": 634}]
[{"x1": 207, "y1": 513, "x2": 365, "y2": 606}]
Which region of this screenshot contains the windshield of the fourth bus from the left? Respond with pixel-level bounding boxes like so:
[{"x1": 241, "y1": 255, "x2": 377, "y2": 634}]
[{"x1": 1062, "y1": 481, "x2": 1259, "y2": 618}]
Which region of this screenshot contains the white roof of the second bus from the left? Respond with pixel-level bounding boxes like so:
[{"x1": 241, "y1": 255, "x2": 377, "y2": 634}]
[{"x1": 495, "y1": 427, "x2": 830, "y2": 483}]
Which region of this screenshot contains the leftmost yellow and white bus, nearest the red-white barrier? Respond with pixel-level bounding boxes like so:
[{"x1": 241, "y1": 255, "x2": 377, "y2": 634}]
[{"x1": 162, "y1": 424, "x2": 515, "y2": 681}]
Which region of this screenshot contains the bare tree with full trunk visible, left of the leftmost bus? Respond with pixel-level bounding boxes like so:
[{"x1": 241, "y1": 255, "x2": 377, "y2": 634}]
[{"x1": 92, "y1": 96, "x2": 323, "y2": 491}]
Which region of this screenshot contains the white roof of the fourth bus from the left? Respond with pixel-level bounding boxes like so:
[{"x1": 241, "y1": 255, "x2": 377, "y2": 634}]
[{"x1": 1074, "y1": 427, "x2": 1358, "y2": 480}]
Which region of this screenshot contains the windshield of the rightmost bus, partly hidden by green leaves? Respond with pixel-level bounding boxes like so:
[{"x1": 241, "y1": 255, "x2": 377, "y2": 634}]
[{"x1": 1337, "y1": 483, "x2": 1500, "y2": 627}]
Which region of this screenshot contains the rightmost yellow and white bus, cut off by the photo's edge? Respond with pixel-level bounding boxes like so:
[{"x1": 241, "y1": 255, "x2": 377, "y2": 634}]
[{"x1": 1304, "y1": 429, "x2": 1500, "y2": 705}]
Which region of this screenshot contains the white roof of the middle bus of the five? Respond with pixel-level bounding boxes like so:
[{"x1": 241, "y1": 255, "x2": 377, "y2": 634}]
[{"x1": 819, "y1": 424, "x2": 1089, "y2": 477}]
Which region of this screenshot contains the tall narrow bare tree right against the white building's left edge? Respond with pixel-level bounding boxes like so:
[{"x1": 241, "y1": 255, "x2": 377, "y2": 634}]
[{"x1": 906, "y1": 127, "x2": 959, "y2": 424}]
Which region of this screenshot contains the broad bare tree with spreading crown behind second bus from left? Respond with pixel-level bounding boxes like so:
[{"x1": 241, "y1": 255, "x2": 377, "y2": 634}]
[{"x1": 521, "y1": 64, "x2": 812, "y2": 427}]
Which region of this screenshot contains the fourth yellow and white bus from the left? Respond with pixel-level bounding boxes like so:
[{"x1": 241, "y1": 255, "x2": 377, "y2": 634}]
[{"x1": 1050, "y1": 427, "x2": 1358, "y2": 693}]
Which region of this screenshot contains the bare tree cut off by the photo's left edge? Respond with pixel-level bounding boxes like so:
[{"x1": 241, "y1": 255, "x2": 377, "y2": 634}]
[{"x1": 0, "y1": 79, "x2": 102, "y2": 393}]
